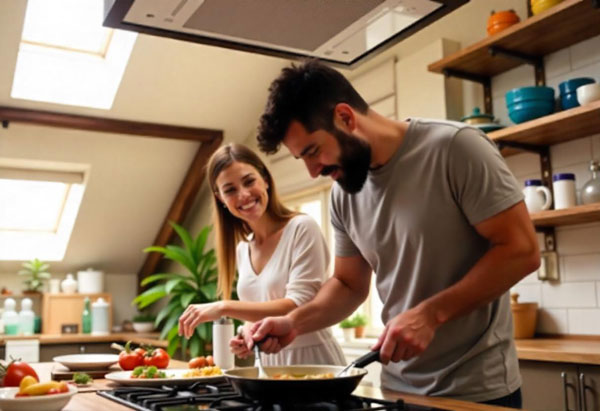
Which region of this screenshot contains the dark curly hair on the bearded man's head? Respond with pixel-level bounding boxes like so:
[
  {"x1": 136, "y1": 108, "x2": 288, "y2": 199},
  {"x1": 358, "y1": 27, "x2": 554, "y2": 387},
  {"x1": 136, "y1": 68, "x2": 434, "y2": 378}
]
[{"x1": 257, "y1": 60, "x2": 369, "y2": 154}]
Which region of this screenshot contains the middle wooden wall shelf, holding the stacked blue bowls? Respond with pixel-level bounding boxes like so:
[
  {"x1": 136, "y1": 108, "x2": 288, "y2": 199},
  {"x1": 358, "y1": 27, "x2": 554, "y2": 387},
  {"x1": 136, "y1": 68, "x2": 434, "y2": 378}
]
[{"x1": 488, "y1": 100, "x2": 600, "y2": 156}]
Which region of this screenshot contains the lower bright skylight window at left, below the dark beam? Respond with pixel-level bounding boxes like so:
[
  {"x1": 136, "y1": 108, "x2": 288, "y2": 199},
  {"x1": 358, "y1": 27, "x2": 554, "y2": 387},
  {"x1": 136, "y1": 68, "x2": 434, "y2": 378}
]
[{"x1": 0, "y1": 160, "x2": 85, "y2": 261}]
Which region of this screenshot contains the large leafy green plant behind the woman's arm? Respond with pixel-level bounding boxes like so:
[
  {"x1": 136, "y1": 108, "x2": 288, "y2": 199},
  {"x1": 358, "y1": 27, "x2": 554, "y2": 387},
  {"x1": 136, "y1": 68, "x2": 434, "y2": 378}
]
[{"x1": 133, "y1": 222, "x2": 217, "y2": 358}]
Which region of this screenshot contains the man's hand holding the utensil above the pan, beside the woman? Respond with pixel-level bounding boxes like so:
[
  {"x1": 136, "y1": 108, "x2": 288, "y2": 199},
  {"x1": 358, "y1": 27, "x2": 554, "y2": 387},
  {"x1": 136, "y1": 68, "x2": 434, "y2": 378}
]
[{"x1": 244, "y1": 316, "x2": 298, "y2": 354}]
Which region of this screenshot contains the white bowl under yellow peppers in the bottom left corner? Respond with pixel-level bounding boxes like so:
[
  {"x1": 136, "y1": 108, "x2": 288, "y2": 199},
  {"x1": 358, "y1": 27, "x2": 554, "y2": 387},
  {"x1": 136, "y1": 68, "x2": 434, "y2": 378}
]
[{"x1": 0, "y1": 384, "x2": 77, "y2": 411}]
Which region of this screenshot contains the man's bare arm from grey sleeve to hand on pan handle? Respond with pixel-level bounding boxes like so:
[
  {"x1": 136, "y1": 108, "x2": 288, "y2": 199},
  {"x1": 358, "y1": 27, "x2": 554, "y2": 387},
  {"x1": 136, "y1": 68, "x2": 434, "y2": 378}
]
[{"x1": 374, "y1": 201, "x2": 540, "y2": 363}]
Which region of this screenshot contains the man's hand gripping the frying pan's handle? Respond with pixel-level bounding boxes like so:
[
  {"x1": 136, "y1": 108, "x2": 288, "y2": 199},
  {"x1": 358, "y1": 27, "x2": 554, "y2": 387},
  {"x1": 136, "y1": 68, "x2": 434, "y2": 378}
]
[{"x1": 372, "y1": 304, "x2": 440, "y2": 364}]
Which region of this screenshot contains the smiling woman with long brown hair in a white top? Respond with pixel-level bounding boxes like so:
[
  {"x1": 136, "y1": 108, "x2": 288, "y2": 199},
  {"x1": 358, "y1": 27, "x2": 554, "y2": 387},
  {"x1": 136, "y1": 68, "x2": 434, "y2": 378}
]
[{"x1": 179, "y1": 144, "x2": 345, "y2": 365}]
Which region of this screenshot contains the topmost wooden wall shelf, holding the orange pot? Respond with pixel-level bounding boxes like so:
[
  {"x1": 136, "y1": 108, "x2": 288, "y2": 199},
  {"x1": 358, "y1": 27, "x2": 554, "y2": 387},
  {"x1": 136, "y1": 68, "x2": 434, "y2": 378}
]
[{"x1": 428, "y1": 0, "x2": 600, "y2": 77}]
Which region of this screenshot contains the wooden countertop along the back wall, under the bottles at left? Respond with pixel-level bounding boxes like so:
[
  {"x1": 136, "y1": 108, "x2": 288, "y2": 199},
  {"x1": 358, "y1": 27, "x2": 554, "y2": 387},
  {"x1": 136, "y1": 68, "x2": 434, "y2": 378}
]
[{"x1": 0, "y1": 332, "x2": 168, "y2": 348}]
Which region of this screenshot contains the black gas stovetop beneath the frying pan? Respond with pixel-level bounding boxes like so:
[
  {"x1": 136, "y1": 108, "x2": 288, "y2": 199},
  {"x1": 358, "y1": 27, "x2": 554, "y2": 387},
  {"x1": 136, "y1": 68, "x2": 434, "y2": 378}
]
[{"x1": 97, "y1": 381, "x2": 442, "y2": 411}]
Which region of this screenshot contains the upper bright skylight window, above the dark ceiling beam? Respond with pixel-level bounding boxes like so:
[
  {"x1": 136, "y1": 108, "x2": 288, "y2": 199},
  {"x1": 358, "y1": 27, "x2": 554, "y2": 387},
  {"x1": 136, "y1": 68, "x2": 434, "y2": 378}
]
[{"x1": 11, "y1": 0, "x2": 137, "y2": 109}]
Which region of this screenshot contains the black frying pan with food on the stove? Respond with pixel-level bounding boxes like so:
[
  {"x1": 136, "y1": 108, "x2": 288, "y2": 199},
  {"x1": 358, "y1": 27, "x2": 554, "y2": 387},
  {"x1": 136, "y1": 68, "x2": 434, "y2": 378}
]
[{"x1": 224, "y1": 351, "x2": 379, "y2": 403}]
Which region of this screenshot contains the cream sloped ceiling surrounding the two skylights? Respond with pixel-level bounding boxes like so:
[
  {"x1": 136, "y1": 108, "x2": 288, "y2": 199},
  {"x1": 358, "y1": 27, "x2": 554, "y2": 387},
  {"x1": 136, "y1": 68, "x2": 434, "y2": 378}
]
[{"x1": 0, "y1": 0, "x2": 288, "y2": 273}]
